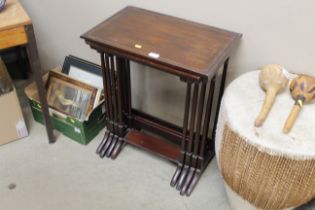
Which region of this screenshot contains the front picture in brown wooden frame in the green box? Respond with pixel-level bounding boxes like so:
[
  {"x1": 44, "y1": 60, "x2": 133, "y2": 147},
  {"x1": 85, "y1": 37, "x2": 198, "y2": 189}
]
[{"x1": 47, "y1": 71, "x2": 98, "y2": 121}]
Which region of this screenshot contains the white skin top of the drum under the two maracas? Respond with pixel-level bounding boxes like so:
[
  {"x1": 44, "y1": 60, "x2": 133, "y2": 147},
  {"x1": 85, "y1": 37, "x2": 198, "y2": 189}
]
[{"x1": 220, "y1": 71, "x2": 315, "y2": 159}]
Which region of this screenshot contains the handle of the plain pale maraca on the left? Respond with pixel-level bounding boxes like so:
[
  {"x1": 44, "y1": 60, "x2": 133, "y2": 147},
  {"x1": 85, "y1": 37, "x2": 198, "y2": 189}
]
[{"x1": 255, "y1": 88, "x2": 278, "y2": 127}]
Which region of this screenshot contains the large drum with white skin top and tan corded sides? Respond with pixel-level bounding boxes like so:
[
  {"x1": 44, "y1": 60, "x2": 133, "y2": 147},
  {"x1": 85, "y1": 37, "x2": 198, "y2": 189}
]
[{"x1": 216, "y1": 71, "x2": 315, "y2": 210}]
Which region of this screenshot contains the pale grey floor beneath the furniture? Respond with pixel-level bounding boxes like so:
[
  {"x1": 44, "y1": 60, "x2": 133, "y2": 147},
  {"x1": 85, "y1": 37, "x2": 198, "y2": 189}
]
[{"x1": 0, "y1": 79, "x2": 314, "y2": 210}]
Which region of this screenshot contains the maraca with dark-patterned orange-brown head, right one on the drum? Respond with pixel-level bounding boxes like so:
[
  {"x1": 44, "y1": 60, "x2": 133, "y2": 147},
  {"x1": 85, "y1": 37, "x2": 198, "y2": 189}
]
[{"x1": 283, "y1": 75, "x2": 315, "y2": 133}]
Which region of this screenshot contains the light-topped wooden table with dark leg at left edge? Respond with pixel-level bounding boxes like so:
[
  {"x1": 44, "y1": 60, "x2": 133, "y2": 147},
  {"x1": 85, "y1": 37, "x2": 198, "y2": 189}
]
[{"x1": 0, "y1": 0, "x2": 55, "y2": 143}]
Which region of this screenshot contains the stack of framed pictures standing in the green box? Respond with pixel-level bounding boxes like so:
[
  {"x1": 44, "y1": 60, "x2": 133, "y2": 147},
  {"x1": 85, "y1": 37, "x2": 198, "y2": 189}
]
[{"x1": 46, "y1": 56, "x2": 104, "y2": 121}]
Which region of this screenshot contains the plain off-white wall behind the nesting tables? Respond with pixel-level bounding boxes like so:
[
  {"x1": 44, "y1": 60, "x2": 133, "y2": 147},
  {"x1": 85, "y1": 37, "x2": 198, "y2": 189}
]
[{"x1": 21, "y1": 0, "x2": 315, "y2": 122}]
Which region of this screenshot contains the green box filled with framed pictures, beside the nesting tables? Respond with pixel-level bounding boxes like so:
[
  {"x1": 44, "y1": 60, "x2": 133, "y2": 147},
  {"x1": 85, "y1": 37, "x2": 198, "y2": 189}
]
[{"x1": 25, "y1": 55, "x2": 106, "y2": 144}]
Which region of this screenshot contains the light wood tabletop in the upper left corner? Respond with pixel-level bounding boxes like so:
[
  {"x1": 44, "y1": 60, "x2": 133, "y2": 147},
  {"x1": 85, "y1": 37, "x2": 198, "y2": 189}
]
[{"x1": 0, "y1": 0, "x2": 32, "y2": 31}]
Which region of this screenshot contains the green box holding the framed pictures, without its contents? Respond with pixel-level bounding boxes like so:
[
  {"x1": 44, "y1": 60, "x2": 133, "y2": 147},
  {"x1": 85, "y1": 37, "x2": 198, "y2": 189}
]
[{"x1": 25, "y1": 70, "x2": 106, "y2": 144}]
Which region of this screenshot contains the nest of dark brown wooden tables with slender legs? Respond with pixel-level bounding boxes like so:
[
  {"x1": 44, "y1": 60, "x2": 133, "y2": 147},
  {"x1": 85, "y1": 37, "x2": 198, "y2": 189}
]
[{"x1": 82, "y1": 7, "x2": 241, "y2": 195}]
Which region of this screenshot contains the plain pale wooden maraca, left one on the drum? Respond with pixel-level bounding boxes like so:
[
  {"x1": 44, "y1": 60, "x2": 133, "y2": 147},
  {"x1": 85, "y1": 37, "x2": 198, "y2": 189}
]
[{"x1": 255, "y1": 64, "x2": 289, "y2": 127}]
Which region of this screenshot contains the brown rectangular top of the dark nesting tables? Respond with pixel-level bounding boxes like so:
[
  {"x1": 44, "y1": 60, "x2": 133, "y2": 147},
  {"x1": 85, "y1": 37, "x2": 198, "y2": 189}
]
[{"x1": 82, "y1": 6, "x2": 241, "y2": 79}]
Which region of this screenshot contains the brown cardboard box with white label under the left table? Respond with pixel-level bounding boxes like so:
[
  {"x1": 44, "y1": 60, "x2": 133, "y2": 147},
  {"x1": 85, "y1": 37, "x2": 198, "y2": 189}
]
[{"x1": 0, "y1": 59, "x2": 28, "y2": 145}]
